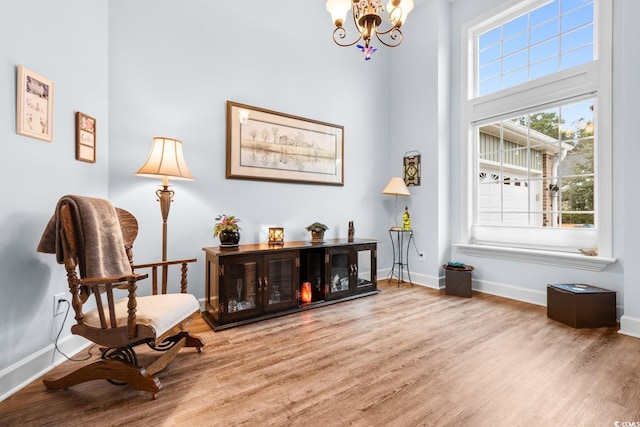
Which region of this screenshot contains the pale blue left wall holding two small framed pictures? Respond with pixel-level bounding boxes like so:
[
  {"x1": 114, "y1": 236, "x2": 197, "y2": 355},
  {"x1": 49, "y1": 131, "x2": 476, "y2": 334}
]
[{"x1": 0, "y1": 0, "x2": 109, "y2": 400}]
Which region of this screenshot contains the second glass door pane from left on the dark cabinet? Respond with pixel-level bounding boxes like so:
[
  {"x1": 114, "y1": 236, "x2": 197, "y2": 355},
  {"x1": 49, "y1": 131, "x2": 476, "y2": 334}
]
[{"x1": 261, "y1": 252, "x2": 298, "y2": 311}]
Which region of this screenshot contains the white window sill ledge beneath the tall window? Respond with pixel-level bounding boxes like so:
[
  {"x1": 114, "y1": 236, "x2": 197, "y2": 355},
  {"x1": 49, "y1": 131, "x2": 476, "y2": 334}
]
[{"x1": 453, "y1": 244, "x2": 617, "y2": 271}]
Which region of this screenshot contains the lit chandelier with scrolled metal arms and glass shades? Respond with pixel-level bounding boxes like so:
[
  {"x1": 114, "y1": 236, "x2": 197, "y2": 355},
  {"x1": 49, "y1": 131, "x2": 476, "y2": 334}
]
[{"x1": 326, "y1": 0, "x2": 413, "y2": 59}]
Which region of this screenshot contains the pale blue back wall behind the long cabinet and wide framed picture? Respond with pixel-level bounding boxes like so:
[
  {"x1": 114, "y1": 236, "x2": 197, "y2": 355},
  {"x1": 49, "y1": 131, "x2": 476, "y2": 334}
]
[{"x1": 109, "y1": 0, "x2": 391, "y2": 298}]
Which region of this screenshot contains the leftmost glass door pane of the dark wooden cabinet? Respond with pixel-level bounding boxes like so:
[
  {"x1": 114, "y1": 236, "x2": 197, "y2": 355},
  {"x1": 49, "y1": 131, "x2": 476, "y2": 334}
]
[{"x1": 220, "y1": 257, "x2": 260, "y2": 317}]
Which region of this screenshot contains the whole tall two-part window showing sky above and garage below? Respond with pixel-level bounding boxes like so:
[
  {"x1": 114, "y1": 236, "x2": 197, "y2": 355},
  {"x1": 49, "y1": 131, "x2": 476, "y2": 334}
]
[{"x1": 463, "y1": 0, "x2": 611, "y2": 256}]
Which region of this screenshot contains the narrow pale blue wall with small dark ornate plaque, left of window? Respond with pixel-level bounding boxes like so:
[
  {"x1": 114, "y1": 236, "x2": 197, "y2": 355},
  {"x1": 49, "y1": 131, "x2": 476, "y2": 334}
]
[{"x1": 383, "y1": 0, "x2": 451, "y2": 288}]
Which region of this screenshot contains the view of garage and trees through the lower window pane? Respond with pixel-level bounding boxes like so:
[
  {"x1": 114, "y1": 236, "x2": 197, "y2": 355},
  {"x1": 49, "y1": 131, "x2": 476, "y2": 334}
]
[{"x1": 478, "y1": 99, "x2": 595, "y2": 227}]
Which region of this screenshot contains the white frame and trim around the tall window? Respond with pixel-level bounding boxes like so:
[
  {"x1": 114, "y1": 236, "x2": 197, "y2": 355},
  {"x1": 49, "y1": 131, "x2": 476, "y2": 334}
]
[{"x1": 455, "y1": 0, "x2": 615, "y2": 271}]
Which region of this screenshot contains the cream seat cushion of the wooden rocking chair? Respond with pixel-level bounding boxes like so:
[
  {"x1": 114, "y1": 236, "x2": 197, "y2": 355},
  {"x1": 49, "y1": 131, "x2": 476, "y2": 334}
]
[{"x1": 84, "y1": 294, "x2": 200, "y2": 337}]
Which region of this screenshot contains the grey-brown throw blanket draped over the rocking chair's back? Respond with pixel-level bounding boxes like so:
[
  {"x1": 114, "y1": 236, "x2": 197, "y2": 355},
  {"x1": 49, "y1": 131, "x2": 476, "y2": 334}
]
[{"x1": 38, "y1": 195, "x2": 131, "y2": 277}]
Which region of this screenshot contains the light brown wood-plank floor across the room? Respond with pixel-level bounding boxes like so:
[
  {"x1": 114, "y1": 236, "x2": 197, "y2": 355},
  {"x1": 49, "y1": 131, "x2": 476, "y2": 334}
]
[{"x1": 0, "y1": 281, "x2": 640, "y2": 427}]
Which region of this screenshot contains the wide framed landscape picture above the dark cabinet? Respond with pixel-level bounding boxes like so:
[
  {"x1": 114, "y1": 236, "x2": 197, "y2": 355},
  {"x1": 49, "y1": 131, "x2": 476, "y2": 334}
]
[{"x1": 226, "y1": 101, "x2": 344, "y2": 185}]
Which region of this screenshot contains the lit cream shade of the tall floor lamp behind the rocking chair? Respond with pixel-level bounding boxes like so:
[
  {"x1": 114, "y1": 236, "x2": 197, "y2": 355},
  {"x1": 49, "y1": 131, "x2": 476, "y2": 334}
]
[{"x1": 135, "y1": 136, "x2": 194, "y2": 181}]
